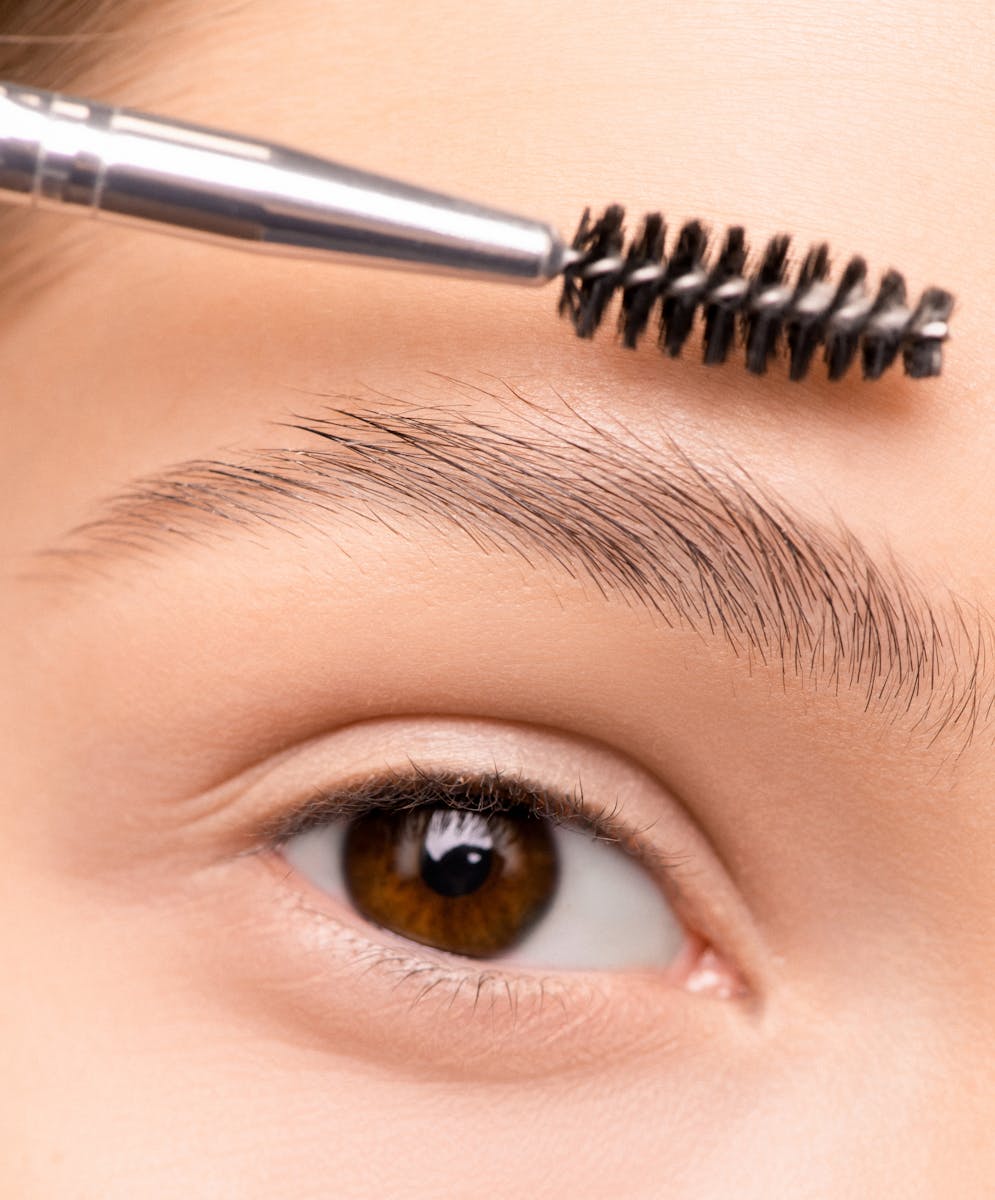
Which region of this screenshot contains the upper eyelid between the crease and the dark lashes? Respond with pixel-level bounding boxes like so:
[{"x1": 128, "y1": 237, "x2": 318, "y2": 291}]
[{"x1": 197, "y1": 715, "x2": 777, "y2": 1003}]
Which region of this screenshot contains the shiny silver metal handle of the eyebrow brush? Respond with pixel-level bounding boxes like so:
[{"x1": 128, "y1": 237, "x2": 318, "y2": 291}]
[{"x1": 0, "y1": 83, "x2": 568, "y2": 283}]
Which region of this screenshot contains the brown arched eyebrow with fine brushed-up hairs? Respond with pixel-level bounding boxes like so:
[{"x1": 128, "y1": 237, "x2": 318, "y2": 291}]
[{"x1": 40, "y1": 380, "x2": 995, "y2": 751}]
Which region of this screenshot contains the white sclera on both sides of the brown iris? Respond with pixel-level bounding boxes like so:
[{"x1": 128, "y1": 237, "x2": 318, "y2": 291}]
[{"x1": 283, "y1": 821, "x2": 684, "y2": 971}]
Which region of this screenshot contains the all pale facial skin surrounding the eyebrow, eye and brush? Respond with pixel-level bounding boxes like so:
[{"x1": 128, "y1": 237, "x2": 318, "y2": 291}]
[{"x1": 0, "y1": 0, "x2": 995, "y2": 1200}]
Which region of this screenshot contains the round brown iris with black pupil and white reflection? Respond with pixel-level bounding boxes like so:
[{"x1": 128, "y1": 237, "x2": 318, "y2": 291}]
[{"x1": 343, "y1": 804, "x2": 557, "y2": 958}]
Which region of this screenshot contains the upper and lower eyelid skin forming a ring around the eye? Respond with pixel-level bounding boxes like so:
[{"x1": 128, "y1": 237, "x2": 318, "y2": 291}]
[{"x1": 198, "y1": 716, "x2": 772, "y2": 1056}]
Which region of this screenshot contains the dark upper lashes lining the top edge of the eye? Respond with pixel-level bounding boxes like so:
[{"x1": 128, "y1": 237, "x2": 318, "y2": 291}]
[{"x1": 255, "y1": 762, "x2": 682, "y2": 875}]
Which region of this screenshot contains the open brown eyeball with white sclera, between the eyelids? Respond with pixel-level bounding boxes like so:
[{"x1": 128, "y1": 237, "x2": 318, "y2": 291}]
[{"x1": 282, "y1": 775, "x2": 685, "y2": 970}]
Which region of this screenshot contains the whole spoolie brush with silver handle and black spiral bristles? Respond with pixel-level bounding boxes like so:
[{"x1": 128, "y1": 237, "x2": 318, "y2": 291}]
[{"x1": 0, "y1": 82, "x2": 953, "y2": 379}]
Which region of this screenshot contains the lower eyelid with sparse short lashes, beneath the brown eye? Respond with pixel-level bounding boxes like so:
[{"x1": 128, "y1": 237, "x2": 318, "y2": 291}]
[{"x1": 241, "y1": 851, "x2": 754, "y2": 1081}]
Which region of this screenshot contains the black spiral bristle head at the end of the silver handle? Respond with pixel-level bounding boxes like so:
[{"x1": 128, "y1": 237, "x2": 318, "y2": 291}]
[{"x1": 559, "y1": 204, "x2": 954, "y2": 380}]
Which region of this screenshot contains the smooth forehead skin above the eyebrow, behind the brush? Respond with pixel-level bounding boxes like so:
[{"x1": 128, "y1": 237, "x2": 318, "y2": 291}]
[{"x1": 5, "y1": 2, "x2": 995, "y2": 564}]
